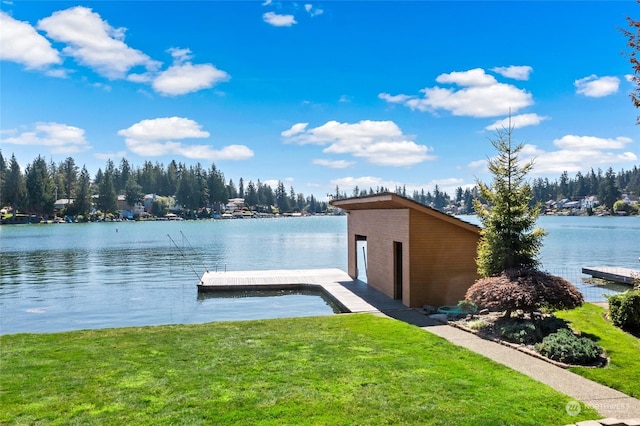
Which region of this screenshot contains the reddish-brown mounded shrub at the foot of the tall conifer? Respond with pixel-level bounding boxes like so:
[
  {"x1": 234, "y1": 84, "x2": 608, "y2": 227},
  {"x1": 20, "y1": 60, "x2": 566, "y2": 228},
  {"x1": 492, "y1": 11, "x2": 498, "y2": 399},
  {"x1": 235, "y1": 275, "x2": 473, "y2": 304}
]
[{"x1": 465, "y1": 269, "x2": 584, "y2": 316}]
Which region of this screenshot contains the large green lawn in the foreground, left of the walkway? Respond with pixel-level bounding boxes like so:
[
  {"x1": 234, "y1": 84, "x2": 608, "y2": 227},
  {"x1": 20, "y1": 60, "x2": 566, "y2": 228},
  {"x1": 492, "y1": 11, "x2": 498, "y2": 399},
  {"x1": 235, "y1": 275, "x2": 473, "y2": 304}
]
[{"x1": 0, "y1": 314, "x2": 599, "y2": 425}]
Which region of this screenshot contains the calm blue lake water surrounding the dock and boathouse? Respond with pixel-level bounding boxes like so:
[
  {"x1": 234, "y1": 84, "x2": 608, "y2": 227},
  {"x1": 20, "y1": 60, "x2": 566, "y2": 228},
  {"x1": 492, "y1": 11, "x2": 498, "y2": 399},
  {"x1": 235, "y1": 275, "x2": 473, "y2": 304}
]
[{"x1": 0, "y1": 216, "x2": 640, "y2": 334}]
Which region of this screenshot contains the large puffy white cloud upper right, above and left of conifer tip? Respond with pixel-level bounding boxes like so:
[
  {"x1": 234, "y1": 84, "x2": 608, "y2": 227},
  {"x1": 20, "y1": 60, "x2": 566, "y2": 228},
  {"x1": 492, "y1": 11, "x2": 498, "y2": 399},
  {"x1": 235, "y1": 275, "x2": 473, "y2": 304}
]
[{"x1": 378, "y1": 68, "x2": 533, "y2": 117}]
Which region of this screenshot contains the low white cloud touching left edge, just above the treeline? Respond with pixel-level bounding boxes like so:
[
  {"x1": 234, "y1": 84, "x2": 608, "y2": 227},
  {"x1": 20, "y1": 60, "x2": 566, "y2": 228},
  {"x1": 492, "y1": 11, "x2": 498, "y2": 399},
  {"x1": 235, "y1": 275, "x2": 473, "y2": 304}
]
[{"x1": 2, "y1": 122, "x2": 91, "y2": 154}]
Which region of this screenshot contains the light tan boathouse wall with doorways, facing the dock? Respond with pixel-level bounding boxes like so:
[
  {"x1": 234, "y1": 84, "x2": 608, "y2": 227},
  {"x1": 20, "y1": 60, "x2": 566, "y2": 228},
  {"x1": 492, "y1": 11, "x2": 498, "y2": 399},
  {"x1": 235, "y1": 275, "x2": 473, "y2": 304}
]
[{"x1": 347, "y1": 209, "x2": 411, "y2": 305}]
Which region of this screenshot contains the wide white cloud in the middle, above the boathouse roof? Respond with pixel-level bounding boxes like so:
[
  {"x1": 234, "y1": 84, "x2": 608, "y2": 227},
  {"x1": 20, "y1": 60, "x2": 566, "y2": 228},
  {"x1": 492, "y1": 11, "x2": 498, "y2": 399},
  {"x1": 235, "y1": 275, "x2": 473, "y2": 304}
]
[{"x1": 281, "y1": 120, "x2": 435, "y2": 166}]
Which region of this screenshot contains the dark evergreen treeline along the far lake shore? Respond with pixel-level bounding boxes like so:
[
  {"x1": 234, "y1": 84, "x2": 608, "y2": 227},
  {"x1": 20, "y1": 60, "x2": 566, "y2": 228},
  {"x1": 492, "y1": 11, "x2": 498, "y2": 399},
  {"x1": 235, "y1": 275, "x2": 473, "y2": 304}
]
[{"x1": 0, "y1": 151, "x2": 640, "y2": 220}]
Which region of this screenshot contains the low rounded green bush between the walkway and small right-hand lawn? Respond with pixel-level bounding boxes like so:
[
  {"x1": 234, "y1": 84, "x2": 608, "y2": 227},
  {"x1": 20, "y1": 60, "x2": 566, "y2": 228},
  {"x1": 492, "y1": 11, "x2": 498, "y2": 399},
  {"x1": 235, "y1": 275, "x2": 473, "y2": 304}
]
[{"x1": 535, "y1": 328, "x2": 603, "y2": 365}]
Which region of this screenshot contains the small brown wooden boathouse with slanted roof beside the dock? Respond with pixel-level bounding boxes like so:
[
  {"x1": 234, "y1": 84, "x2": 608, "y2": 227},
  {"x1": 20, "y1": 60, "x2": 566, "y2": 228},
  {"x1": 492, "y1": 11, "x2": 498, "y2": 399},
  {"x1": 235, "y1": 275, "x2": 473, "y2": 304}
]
[{"x1": 330, "y1": 193, "x2": 480, "y2": 308}]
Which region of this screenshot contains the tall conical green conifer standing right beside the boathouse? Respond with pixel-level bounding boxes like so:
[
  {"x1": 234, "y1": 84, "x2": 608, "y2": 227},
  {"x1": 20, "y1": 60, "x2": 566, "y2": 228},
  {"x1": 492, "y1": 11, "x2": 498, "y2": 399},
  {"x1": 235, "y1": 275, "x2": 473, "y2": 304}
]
[{"x1": 474, "y1": 125, "x2": 545, "y2": 277}]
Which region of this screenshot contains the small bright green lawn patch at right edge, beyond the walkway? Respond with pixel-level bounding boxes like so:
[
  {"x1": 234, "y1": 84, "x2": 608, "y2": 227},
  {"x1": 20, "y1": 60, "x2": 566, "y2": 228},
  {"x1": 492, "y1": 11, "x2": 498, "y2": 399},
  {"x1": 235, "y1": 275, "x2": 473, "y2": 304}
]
[{"x1": 555, "y1": 303, "x2": 640, "y2": 398}]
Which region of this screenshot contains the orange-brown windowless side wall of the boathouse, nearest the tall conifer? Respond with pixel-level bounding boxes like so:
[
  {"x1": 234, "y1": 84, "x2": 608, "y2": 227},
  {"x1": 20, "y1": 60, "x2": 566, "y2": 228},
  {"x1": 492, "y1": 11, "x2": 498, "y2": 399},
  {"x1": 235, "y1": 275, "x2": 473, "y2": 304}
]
[{"x1": 408, "y1": 210, "x2": 479, "y2": 307}]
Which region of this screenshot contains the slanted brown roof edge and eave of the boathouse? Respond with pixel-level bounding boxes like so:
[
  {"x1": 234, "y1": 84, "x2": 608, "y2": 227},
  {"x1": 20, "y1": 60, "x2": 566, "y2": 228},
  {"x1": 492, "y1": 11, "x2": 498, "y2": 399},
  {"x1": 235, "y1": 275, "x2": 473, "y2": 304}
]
[{"x1": 329, "y1": 192, "x2": 481, "y2": 234}]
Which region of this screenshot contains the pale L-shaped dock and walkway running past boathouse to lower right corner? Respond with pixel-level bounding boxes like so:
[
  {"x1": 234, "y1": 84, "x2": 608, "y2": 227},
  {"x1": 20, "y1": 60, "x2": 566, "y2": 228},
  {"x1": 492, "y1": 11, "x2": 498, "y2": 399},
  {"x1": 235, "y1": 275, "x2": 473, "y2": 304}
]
[{"x1": 198, "y1": 269, "x2": 640, "y2": 425}]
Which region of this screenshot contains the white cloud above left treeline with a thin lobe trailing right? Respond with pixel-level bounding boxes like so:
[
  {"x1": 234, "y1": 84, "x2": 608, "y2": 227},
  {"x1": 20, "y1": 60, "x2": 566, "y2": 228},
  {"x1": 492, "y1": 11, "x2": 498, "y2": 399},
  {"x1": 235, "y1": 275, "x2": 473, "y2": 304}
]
[{"x1": 118, "y1": 117, "x2": 253, "y2": 161}]
